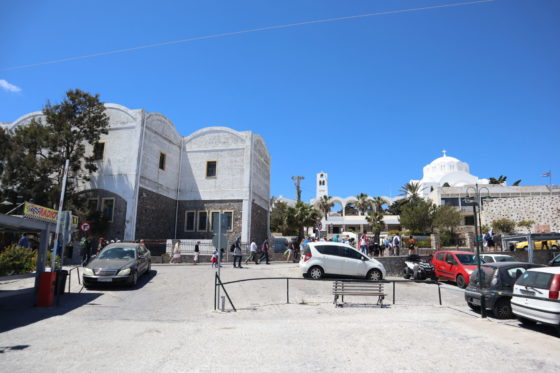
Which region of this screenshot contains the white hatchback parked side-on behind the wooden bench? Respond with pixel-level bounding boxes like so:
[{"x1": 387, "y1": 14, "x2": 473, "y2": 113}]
[{"x1": 299, "y1": 242, "x2": 387, "y2": 280}]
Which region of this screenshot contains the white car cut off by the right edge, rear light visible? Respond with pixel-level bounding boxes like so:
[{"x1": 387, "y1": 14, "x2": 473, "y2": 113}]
[{"x1": 511, "y1": 267, "x2": 560, "y2": 327}]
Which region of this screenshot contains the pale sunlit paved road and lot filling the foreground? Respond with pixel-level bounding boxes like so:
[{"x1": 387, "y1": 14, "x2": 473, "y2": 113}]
[{"x1": 0, "y1": 264, "x2": 560, "y2": 373}]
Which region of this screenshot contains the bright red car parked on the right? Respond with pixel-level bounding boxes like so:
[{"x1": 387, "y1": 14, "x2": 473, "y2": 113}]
[{"x1": 432, "y1": 250, "x2": 477, "y2": 289}]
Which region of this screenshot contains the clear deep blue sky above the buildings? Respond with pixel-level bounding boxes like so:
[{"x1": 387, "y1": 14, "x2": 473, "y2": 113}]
[{"x1": 0, "y1": 0, "x2": 560, "y2": 199}]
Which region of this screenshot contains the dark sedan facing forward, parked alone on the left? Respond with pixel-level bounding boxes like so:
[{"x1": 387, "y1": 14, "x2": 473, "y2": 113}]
[{"x1": 82, "y1": 243, "x2": 152, "y2": 288}]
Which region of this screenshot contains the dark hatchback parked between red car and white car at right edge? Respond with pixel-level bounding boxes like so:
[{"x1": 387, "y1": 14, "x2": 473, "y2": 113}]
[{"x1": 465, "y1": 262, "x2": 542, "y2": 319}]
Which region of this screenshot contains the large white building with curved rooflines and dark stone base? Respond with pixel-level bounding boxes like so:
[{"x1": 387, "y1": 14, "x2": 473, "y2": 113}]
[{"x1": 0, "y1": 104, "x2": 270, "y2": 242}]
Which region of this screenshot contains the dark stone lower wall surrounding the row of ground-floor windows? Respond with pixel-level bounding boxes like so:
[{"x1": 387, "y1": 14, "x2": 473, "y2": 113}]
[{"x1": 177, "y1": 200, "x2": 243, "y2": 245}]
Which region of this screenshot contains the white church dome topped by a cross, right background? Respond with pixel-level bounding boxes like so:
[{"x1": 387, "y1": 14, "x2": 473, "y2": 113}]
[{"x1": 410, "y1": 150, "x2": 489, "y2": 197}]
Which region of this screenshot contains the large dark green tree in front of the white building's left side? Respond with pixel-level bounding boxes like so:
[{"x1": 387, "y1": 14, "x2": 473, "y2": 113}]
[{"x1": 2, "y1": 89, "x2": 109, "y2": 209}]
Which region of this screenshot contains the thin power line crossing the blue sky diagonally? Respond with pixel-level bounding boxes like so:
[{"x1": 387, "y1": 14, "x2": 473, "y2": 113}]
[{"x1": 0, "y1": 0, "x2": 496, "y2": 71}]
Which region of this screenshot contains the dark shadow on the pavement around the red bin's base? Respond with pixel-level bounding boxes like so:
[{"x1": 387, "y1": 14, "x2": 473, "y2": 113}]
[{"x1": 0, "y1": 292, "x2": 101, "y2": 332}]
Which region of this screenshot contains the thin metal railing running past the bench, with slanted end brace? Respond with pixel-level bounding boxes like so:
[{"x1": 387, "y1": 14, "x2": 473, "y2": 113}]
[{"x1": 214, "y1": 272, "x2": 442, "y2": 312}]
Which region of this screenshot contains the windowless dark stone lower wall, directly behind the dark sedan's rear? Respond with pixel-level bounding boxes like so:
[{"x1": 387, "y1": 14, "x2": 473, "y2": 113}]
[{"x1": 135, "y1": 188, "x2": 177, "y2": 239}]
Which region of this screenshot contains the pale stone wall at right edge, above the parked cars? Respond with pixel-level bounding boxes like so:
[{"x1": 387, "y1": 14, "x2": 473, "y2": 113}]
[{"x1": 481, "y1": 194, "x2": 560, "y2": 233}]
